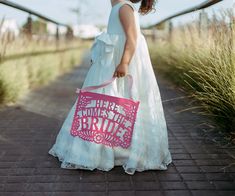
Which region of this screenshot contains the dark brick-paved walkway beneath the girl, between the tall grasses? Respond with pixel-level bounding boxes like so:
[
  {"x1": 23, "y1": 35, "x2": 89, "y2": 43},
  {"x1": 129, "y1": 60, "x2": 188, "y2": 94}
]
[{"x1": 0, "y1": 51, "x2": 235, "y2": 196}]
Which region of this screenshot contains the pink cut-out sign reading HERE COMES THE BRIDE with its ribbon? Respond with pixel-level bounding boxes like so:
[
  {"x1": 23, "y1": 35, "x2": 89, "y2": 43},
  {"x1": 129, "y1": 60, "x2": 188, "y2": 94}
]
[{"x1": 70, "y1": 75, "x2": 140, "y2": 148}]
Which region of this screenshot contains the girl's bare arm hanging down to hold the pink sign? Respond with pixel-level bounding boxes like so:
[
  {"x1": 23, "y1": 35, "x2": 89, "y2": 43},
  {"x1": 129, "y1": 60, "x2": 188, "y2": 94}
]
[{"x1": 113, "y1": 4, "x2": 137, "y2": 77}]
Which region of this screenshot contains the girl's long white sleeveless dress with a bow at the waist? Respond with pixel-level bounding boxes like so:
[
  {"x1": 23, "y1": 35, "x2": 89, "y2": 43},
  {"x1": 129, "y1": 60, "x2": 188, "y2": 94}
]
[{"x1": 48, "y1": 0, "x2": 172, "y2": 174}]
